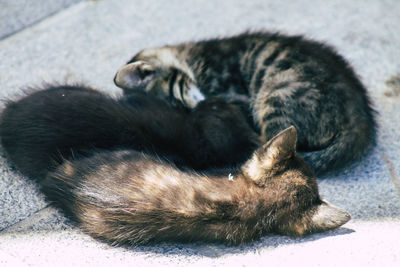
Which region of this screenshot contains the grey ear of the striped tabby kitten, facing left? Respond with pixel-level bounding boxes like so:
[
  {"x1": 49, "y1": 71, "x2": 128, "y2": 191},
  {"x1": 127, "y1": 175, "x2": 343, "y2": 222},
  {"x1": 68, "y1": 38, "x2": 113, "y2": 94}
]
[{"x1": 114, "y1": 60, "x2": 156, "y2": 90}]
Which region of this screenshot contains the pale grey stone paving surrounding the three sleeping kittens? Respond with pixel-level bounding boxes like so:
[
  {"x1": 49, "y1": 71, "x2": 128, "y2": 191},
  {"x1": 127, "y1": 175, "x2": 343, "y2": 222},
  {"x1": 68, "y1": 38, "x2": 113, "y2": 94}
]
[{"x1": 0, "y1": 0, "x2": 400, "y2": 266}]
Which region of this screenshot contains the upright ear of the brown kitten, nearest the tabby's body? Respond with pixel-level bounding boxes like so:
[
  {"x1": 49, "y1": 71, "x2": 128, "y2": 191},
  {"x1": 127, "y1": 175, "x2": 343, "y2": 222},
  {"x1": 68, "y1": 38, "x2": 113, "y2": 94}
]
[{"x1": 258, "y1": 126, "x2": 297, "y2": 168}]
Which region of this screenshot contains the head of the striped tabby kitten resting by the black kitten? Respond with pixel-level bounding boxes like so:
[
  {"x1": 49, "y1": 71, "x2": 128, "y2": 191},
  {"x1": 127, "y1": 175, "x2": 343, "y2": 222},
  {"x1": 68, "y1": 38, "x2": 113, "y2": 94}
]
[{"x1": 114, "y1": 48, "x2": 205, "y2": 108}]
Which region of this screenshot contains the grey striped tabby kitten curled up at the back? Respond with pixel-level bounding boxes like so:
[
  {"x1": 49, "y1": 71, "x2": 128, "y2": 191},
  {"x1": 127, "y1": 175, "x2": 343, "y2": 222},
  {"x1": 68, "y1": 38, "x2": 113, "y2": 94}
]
[{"x1": 114, "y1": 32, "x2": 377, "y2": 175}]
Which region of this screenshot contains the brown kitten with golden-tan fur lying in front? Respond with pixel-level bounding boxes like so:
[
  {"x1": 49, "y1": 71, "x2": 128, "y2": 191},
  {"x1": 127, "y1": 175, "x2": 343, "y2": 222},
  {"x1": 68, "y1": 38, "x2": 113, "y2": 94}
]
[{"x1": 42, "y1": 127, "x2": 350, "y2": 245}]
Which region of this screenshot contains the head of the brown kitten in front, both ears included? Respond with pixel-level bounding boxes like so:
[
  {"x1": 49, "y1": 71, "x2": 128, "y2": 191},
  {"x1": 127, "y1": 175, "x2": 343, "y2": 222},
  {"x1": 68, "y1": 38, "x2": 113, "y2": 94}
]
[{"x1": 242, "y1": 126, "x2": 350, "y2": 236}]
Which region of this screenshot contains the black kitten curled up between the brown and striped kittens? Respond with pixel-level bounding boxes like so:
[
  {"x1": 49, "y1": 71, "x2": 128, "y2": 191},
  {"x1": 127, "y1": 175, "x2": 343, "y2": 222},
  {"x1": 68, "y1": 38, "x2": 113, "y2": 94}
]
[{"x1": 0, "y1": 86, "x2": 259, "y2": 180}]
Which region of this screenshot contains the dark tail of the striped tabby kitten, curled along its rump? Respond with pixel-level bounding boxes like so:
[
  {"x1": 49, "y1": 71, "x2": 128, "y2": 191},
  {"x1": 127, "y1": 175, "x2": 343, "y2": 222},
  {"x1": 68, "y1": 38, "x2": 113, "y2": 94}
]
[{"x1": 300, "y1": 119, "x2": 377, "y2": 175}]
